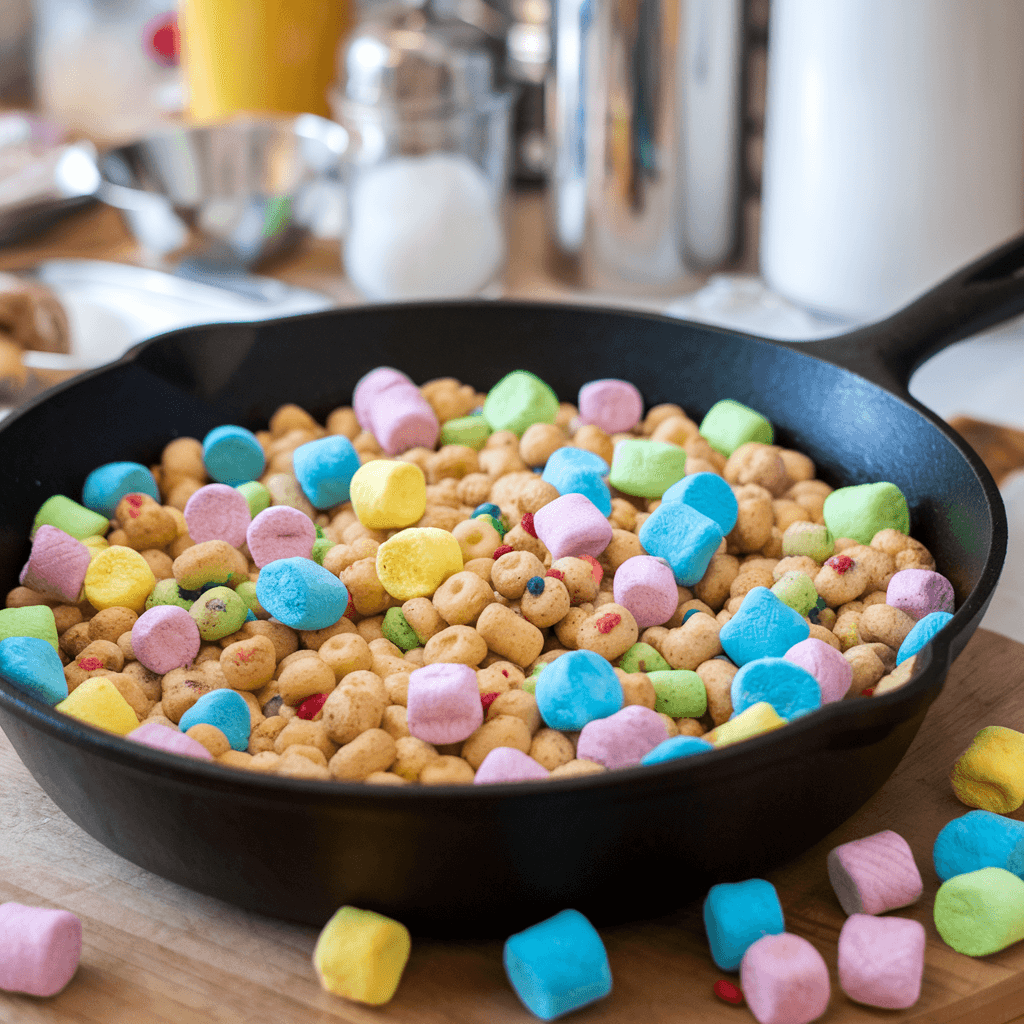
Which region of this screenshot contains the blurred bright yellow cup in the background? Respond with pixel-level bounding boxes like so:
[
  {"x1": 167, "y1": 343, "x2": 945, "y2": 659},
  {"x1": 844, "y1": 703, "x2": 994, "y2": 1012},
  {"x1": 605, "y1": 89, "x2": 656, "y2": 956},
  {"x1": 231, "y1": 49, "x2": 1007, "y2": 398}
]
[{"x1": 181, "y1": 0, "x2": 350, "y2": 123}]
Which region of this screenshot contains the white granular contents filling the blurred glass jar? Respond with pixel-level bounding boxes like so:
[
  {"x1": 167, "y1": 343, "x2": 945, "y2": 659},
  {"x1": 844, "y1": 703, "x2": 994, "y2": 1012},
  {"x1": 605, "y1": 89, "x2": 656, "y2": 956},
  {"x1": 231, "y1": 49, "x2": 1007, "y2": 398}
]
[{"x1": 345, "y1": 153, "x2": 505, "y2": 299}]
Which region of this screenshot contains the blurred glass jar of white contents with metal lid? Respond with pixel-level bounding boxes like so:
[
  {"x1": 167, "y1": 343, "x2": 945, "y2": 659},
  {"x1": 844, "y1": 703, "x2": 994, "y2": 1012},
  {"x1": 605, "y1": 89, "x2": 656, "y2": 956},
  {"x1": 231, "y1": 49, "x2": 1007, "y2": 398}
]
[{"x1": 331, "y1": 0, "x2": 514, "y2": 300}]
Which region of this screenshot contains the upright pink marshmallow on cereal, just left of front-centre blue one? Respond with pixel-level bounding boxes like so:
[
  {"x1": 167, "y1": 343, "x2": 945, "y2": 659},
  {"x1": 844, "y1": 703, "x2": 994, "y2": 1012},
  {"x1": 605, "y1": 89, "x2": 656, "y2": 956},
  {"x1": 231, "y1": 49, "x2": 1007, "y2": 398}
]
[{"x1": 407, "y1": 663, "x2": 483, "y2": 743}]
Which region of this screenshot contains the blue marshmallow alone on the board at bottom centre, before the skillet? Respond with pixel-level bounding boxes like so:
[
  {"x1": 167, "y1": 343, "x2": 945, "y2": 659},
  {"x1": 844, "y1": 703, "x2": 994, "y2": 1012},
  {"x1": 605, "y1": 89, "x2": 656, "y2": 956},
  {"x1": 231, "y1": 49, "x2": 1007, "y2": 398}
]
[{"x1": 504, "y1": 910, "x2": 611, "y2": 1021}]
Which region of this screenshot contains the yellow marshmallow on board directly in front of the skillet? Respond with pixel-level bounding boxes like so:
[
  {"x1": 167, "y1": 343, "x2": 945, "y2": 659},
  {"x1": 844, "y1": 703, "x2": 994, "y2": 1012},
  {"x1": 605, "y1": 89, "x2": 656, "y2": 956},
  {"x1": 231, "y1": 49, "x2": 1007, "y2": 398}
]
[{"x1": 313, "y1": 906, "x2": 412, "y2": 1007}]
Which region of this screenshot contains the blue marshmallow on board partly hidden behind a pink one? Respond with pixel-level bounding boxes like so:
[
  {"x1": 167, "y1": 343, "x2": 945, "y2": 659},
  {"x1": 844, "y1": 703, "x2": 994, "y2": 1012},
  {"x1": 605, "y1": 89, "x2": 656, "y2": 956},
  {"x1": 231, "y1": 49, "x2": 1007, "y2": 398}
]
[{"x1": 703, "y1": 879, "x2": 785, "y2": 971}]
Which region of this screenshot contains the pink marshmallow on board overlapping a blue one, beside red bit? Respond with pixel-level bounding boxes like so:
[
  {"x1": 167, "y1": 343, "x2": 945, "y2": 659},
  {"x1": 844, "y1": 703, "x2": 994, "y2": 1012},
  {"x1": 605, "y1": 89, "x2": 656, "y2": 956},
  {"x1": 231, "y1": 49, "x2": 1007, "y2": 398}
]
[{"x1": 739, "y1": 932, "x2": 831, "y2": 1024}]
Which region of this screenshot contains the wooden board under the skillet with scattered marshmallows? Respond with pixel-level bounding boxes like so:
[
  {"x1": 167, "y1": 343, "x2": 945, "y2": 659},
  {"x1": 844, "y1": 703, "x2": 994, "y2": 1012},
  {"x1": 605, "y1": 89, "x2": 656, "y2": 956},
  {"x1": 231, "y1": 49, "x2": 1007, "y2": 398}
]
[{"x1": 0, "y1": 630, "x2": 1024, "y2": 1024}]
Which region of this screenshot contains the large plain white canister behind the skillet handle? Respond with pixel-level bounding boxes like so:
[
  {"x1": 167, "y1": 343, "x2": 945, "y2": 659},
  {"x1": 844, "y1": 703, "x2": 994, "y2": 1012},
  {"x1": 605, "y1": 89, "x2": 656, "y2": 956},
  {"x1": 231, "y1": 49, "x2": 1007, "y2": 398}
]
[{"x1": 761, "y1": 0, "x2": 1024, "y2": 319}]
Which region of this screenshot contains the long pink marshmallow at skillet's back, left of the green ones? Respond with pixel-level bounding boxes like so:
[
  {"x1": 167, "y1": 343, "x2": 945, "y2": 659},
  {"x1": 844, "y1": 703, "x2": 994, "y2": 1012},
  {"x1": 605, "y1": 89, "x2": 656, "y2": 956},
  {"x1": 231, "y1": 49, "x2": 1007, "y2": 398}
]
[{"x1": 352, "y1": 367, "x2": 440, "y2": 455}]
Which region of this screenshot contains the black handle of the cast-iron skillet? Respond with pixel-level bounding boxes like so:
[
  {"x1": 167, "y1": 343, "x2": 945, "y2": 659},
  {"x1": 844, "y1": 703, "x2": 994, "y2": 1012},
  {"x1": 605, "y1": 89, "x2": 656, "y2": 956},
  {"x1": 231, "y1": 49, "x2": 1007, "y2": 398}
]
[{"x1": 792, "y1": 234, "x2": 1024, "y2": 397}]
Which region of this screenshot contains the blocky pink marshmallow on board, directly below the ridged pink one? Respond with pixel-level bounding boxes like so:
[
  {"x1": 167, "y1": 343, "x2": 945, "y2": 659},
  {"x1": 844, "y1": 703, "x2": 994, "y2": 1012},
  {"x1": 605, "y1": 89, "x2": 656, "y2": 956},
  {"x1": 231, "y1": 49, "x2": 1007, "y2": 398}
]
[{"x1": 839, "y1": 913, "x2": 925, "y2": 1010}]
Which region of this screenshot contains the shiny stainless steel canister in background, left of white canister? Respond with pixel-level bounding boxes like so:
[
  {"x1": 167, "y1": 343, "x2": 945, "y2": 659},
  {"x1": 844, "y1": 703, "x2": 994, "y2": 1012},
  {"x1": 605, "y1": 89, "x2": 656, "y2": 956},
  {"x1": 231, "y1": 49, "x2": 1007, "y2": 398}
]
[{"x1": 549, "y1": 0, "x2": 743, "y2": 291}]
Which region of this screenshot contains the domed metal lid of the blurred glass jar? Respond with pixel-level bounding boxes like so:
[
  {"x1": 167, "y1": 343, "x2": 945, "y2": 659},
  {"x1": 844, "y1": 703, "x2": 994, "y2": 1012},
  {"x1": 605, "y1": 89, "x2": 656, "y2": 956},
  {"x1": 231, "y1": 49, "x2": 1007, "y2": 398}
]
[{"x1": 335, "y1": 0, "x2": 500, "y2": 114}]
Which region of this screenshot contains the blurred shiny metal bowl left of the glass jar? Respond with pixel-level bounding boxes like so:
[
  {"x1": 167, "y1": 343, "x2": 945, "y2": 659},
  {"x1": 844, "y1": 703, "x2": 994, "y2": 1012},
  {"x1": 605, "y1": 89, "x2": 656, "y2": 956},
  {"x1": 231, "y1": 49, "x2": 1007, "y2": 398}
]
[{"x1": 99, "y1": 114, "x2": 347, "y2": 296}]
